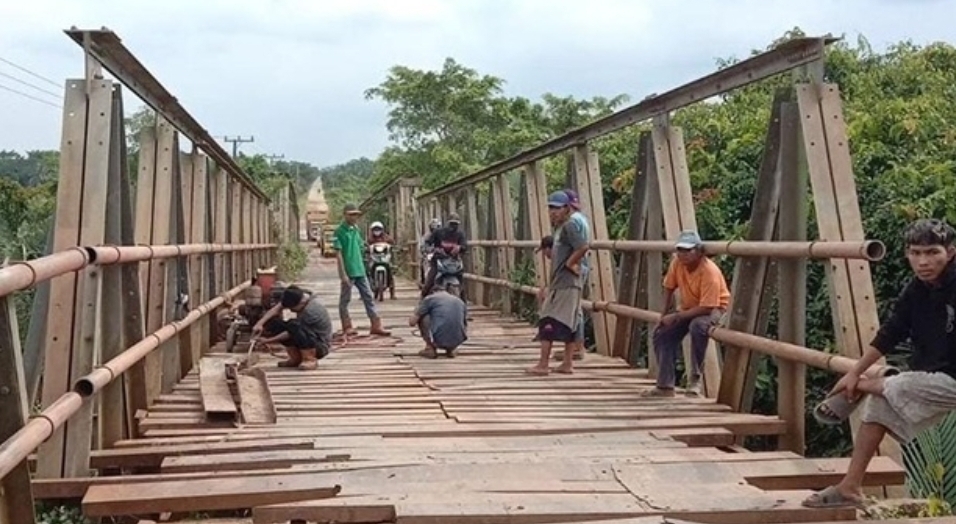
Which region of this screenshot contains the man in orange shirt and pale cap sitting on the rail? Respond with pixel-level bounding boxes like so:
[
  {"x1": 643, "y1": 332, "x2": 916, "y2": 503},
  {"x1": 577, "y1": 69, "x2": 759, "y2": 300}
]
[{"x1": 648, "y1": 231, "x2": 730, "y2": 397}]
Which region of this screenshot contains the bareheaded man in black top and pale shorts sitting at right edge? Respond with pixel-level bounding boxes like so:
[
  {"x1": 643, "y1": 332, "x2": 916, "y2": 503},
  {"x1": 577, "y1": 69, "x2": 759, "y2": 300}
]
[{"x1": 803, "y1": 220, "x2": 956, "y2": 507}]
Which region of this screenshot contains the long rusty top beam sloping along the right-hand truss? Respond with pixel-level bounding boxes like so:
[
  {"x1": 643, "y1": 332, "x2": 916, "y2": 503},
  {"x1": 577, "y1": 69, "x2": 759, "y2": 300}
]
[{"x1": 418, "y1": 37, "x2": 839, "y2": 200}]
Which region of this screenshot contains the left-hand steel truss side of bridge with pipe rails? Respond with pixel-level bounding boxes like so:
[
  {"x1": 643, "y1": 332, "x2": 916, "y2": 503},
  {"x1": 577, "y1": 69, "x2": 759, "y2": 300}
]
[{"x1": 0, "y1": 29, "x2": 298, "y2": 524}]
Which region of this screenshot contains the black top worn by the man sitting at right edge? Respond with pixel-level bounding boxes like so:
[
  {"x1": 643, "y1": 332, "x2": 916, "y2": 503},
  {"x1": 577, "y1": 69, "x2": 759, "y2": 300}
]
[{"x1": 870, "y1": 262, "x2": 956, "y2": 378}]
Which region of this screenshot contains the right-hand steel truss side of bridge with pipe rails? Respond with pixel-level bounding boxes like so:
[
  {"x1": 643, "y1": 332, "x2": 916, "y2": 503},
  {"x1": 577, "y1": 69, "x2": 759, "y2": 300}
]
[{"x1": 376, "y1": 34, "x2": 899, "y2": 472}]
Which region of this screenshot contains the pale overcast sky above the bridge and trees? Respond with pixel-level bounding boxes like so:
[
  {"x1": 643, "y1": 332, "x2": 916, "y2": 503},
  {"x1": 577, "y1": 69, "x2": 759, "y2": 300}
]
[{"x1": 0, "y1": 0, "x2": 956, "y2": 166}]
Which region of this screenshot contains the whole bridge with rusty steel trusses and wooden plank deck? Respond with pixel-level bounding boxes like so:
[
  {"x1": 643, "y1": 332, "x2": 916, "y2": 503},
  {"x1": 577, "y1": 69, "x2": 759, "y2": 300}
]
[{"x1": 0, "y1": 28, "x2": 940, "y2": 524}]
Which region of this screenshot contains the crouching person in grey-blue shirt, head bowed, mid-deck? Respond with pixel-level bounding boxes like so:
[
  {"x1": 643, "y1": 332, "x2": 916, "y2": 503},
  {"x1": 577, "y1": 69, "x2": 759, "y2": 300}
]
[{"x1": 408, "y1": 284, "x2": 468, "y2": 358}]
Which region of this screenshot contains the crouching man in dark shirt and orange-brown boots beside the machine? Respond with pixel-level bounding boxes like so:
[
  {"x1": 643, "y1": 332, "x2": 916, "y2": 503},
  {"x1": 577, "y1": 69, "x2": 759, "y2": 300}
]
[{"x1": 252, "y1": 286, "x2": 332, "y2": 369}]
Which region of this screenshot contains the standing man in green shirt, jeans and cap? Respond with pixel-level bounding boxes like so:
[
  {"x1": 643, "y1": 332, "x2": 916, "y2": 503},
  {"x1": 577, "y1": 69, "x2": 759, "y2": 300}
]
[{"x1": 332, "y1": 204, "x2": 391, "y2": 338}]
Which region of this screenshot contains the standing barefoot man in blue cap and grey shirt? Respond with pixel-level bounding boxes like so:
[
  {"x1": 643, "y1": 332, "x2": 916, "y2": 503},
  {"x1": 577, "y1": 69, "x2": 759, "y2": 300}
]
[{"x1": 527, "y1": 191, "x2": 588, "y2": 375}]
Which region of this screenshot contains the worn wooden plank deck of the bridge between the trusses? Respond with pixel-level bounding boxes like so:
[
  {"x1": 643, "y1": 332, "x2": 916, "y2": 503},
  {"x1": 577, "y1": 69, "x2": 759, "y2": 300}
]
[{"x1": 44, "y1": 261, "x2": 903, "y2": 524}]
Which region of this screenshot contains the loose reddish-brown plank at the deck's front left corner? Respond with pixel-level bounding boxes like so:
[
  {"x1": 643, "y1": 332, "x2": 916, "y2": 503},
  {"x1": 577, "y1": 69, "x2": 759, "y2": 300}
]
[{"x1": 83, "y1": 475, "x2": 342, "y2": 517}]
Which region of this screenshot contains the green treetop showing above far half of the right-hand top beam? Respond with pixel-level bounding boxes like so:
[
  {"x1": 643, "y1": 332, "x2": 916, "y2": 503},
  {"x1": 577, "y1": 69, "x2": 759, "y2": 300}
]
[{"x1": 366, "y1": 58, "x2": 627, "y2": 189}]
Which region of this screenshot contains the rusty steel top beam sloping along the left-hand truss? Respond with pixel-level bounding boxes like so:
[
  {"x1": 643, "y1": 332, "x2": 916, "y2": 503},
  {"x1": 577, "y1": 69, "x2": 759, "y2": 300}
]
[{"x1": 64, "y1": 27, "x2": 270, "y2": 202}]
